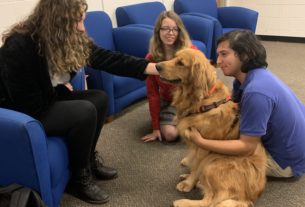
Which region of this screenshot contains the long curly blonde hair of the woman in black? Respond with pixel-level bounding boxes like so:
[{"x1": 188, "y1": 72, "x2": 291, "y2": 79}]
[{"x1": 2, "y1": 0, "x2": 92, "y2": 74}]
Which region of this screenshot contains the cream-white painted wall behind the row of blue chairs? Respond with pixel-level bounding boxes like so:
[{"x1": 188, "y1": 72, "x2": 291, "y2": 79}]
[{"x1": 0, "y1": 0, "x2": 305, "y2": 37}]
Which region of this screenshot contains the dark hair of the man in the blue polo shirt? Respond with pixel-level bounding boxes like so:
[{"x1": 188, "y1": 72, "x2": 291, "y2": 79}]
[{"x1": 217, "y1": 30, "x2": 268, "y2": 73}]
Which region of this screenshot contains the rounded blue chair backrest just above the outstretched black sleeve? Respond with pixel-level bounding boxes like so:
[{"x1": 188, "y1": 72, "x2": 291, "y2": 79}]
[{"x1": 85, "y1": 11, "x2": 115, "y2": 50}]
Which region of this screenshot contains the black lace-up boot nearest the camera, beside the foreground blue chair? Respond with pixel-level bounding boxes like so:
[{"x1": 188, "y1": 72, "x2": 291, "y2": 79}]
[{"x1": 68, "y1": 168, "x2": 109, "y2": 204}]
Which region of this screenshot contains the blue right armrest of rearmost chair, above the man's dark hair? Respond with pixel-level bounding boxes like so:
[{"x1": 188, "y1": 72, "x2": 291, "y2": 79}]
[{"x1": 218, "y1": 6, "x2": 258, "y2": 32}]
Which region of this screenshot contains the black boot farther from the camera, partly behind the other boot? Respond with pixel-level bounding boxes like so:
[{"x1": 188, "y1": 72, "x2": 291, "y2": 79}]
[{"x1": 90, "y1": 151, "x2": 118, "y2": 180}]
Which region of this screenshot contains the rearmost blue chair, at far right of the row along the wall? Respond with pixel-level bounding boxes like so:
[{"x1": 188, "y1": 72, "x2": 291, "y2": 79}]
[{"x1": 174, "y1": 0, "x2": 258, "y2": 60}]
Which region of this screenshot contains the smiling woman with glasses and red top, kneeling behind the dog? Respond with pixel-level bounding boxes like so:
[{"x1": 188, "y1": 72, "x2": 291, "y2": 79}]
[{"x1": 142, "y1": 11, "x2": 195, "y2": 142}]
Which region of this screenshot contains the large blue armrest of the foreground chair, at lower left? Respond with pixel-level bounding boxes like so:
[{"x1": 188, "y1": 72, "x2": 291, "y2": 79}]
[{"x1": 0, "y1": 108, "x2": 53, "y2": 206}]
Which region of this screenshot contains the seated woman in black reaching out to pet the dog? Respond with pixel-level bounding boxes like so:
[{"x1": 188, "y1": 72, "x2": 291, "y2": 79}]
[{"x1": 0, "y1": 0, "x2": 158, "y2": 203}]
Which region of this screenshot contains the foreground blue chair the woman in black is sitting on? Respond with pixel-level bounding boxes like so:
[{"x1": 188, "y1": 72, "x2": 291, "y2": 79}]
[{"x1": 0, "y1": 69, "x2": 85, "y2": 207}]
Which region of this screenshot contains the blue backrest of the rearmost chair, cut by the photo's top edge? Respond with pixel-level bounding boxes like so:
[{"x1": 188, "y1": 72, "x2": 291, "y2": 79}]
[{"x1": 174, "y1": 0, "x2": 218, "y2": 19}]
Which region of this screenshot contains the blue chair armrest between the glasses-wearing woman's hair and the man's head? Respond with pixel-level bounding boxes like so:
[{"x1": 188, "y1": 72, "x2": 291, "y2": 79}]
[{"x1": 180, "y1": 14, "x2": 214, "y2": 58}]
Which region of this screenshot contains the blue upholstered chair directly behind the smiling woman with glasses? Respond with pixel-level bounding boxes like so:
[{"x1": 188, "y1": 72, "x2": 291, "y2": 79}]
[{"x1": 116, "y1": 1, "x2": 214, "y2": 58}]
